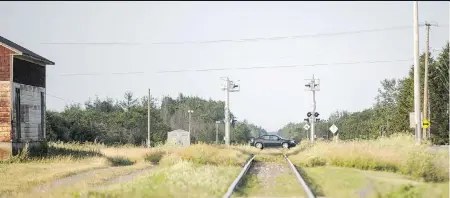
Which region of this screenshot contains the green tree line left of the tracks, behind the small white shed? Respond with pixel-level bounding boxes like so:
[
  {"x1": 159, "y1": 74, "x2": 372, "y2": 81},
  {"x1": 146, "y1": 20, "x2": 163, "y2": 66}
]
[{"x1": 46, "y1": 92, "x2": 267, "y2": 146}]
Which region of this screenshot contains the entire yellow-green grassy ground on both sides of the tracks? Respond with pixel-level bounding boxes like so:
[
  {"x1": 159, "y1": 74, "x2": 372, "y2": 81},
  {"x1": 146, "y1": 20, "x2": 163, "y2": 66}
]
[{"x1": 0, "y1": 136, "x2": 449, "y2": 197}]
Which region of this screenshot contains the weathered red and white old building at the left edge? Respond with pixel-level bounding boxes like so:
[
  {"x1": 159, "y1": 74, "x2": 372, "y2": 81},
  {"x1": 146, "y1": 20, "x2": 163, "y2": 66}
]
[{"x1": 0, "y1": 36, "x2": 55, "y2": 159}]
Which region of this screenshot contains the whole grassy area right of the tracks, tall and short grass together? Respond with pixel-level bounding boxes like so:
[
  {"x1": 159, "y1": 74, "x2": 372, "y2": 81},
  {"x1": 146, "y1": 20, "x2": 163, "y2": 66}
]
[{"x1": 289, "y1": 135, "x2": 449, "y2": 198}]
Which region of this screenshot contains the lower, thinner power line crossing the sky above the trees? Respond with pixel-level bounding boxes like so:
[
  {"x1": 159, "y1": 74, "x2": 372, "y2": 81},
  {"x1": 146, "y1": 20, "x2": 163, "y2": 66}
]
[{"x1": 60, "y1": 58, "x2": 413, "y2": 76}]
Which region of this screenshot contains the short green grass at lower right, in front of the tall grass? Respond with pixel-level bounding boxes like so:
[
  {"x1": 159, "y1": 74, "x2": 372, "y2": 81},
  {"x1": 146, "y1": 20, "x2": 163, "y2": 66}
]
[{"x1": 302, "y1": 166, "x2": 449, "y2": 198}]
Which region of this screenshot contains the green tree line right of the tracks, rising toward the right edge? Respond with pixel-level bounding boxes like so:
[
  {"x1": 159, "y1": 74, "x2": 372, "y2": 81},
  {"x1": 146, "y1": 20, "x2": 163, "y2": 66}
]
[{"x1": 278, "y1": 41, "x2": 449, "y2": 144}]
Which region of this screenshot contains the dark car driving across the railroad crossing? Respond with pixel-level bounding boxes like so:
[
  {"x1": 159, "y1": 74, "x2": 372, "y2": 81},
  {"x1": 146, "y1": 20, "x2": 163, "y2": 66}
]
[{"x1": 250, "y1": 135, "x2": 297, "y2": 149}]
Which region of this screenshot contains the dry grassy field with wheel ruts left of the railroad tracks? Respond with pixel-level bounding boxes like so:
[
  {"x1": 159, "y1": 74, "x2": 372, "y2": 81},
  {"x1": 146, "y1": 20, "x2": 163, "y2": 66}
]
[{"x1": 0, "y1": 143, "x2": 252, "y2": 197}]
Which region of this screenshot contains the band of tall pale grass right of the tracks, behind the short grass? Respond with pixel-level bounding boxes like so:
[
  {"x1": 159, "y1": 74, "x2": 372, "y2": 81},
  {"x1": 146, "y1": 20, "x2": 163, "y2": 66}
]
[{"x1": 290, "y1": 134, "x2": 449, "y2": 182}]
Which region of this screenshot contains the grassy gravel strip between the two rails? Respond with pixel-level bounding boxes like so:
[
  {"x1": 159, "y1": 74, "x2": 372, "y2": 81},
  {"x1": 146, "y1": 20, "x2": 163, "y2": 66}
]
[{"x1": 233, "y1": 161, "x2": 306, "y2": 197}]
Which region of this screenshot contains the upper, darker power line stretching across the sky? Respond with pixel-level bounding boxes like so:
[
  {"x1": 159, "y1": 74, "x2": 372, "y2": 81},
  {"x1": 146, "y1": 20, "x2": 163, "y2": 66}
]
[{"x1": 40, "y1": 24, "x2": 448, "y2": 45}]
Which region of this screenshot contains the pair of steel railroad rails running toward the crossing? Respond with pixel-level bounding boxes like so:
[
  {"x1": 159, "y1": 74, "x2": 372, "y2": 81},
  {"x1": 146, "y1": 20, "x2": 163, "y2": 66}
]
[{"x1": 223, "y1": 154, "x2": 316, "y2": 198}]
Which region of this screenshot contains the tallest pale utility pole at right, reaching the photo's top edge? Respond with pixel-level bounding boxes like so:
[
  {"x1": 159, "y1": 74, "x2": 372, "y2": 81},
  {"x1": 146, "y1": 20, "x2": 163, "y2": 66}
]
[{"x1": 413, "y1": 1, "x2": 422, "y2": 144}]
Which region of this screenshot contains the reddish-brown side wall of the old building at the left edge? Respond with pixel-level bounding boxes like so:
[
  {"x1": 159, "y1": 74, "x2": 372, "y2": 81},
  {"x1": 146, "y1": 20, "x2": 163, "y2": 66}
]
[{"x1": 0, "y1": 45, "x2": 14, "y2": 142}]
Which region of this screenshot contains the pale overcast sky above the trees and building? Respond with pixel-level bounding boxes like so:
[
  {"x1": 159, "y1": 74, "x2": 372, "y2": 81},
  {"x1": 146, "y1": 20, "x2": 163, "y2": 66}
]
[{"x1": 0, "y1": 1, "x2": 449, "y2": 131}]
